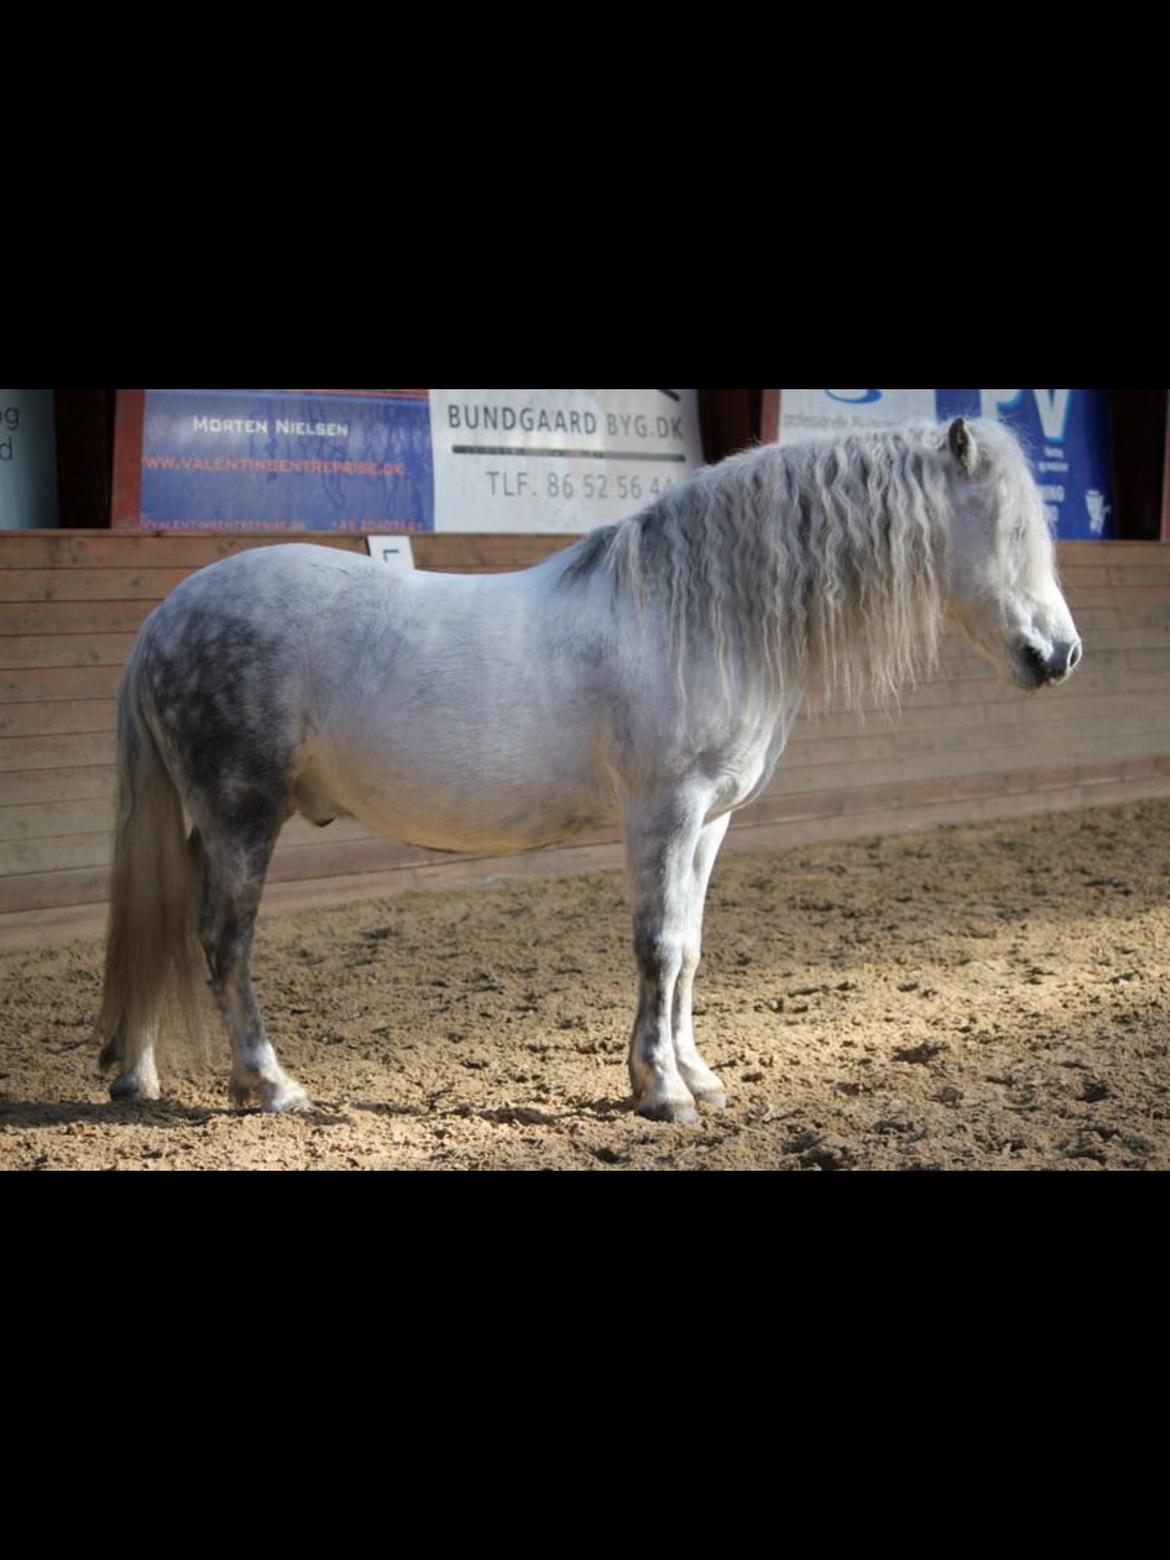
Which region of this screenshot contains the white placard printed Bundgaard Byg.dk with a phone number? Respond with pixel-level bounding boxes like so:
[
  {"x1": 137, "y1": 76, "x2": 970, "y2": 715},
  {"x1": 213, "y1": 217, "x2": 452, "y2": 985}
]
[{"x1": 431, "y1": 390, "x2": 702, "y2": 532}]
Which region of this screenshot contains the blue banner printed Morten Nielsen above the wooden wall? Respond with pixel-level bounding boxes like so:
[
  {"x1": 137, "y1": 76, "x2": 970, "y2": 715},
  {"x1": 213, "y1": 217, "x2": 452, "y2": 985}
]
[{"x1": 140, "y1": 390, "x2": 434, "y2": 532}]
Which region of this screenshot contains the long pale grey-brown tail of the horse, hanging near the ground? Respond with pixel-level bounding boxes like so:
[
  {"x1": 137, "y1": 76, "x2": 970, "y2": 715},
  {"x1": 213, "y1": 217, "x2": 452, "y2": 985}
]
[{"x1": 98, "y1": 640, "x2": 206, "y2": 1075}]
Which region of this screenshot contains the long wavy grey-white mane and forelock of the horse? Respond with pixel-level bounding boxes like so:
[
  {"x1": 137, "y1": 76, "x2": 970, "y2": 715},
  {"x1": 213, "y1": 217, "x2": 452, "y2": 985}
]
[{"x1": 560, "y1": 421, "x2": 1034, "y2": 704}]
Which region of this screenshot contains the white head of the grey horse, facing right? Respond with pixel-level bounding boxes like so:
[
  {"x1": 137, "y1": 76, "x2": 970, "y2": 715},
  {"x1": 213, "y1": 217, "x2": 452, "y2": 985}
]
[{"x1": 942, "y1": 418, "x2": 1081, "y2": 690}]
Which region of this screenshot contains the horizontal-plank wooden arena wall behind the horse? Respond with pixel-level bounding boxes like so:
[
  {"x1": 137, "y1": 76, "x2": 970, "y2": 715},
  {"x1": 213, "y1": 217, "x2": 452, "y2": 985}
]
[{"x1": 0, "y1": 530, "x2": 1170, "y2": 939}]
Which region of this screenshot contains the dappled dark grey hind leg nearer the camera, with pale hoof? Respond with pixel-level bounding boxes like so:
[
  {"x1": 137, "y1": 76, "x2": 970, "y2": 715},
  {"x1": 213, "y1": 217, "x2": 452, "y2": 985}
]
[{"x1": 200, "y1": 807, "x2": 312, "y2": 1111}]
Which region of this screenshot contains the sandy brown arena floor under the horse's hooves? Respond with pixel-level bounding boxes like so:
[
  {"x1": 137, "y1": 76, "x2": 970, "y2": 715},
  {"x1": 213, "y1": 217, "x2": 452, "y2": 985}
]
[{"x1": 0, "y1": 802, "x2": 1170, "y2": 1170}]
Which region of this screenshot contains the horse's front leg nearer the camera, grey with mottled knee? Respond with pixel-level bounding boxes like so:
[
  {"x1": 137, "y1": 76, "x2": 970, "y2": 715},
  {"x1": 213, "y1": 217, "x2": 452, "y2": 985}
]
[{"x1": 626, "y1": 797, "x2": 718, "y2": 1122}]
